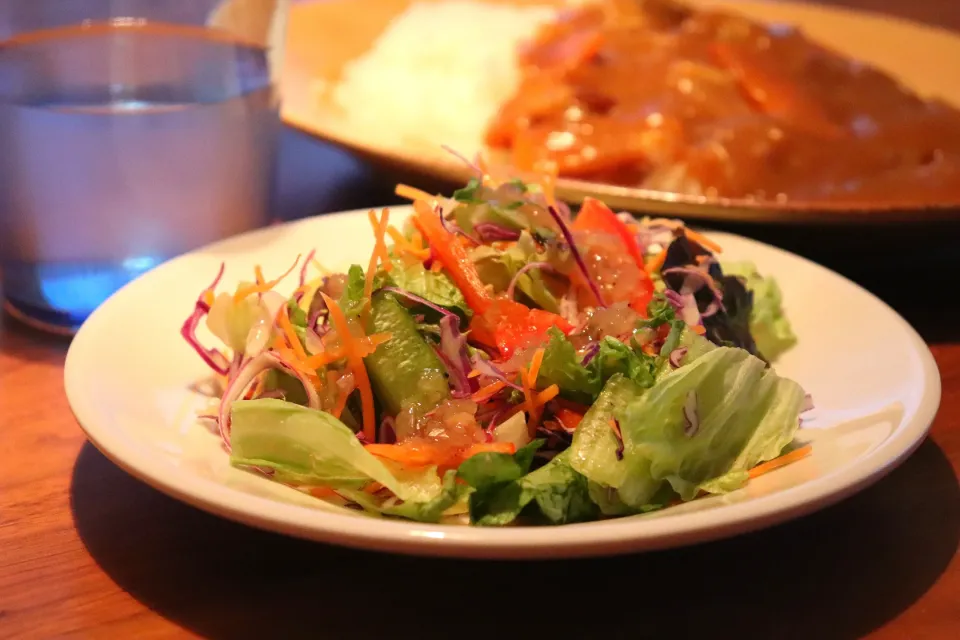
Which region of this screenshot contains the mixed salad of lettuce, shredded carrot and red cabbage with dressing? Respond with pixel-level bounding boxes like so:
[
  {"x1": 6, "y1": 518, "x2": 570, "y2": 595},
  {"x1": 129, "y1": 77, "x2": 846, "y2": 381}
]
[{"x1": 182, "y1": 156, "x2": 812, "y2": 526}]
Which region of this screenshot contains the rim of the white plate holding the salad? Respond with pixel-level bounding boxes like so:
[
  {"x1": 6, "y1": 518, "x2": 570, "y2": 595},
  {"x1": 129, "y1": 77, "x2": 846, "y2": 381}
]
[{"x1": 64, "y1": 206, "x2": 941, "y2": 559}]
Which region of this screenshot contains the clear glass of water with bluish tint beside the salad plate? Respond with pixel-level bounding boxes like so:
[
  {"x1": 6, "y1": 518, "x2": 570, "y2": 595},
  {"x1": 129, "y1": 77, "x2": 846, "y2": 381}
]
[{"x1": 0, "y1": 0, "x2": 287, "y2": 333}]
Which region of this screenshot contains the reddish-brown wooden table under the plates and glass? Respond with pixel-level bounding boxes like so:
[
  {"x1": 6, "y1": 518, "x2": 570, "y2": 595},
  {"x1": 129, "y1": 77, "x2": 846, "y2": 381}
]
[{"x1": 0, "y1": 0, "x2": 960, "y2": 638}]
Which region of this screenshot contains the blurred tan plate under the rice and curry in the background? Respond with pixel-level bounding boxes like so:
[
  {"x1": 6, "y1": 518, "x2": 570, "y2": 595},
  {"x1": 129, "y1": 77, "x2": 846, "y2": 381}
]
[{"x1": 283, "y1": 0, "x2": 960, "y2": 225}]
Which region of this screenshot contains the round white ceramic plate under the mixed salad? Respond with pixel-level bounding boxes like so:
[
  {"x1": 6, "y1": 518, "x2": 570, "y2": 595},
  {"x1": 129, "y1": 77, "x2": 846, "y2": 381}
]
[{"x1": 65, "y1": 208, "x2": 940, "y2": 558}]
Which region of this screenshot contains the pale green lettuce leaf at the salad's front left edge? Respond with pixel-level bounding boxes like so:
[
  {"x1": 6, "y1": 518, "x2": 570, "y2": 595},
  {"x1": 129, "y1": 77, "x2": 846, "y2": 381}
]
[{"x1": 230, "y1": 398, "x2": 441, "y2": 502}]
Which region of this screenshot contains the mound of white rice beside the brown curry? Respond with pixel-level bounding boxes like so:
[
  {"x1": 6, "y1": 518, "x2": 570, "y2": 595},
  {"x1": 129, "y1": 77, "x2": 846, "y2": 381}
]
[{"x1": 333, "y1": 0, "x2": 555, "y2": 157}]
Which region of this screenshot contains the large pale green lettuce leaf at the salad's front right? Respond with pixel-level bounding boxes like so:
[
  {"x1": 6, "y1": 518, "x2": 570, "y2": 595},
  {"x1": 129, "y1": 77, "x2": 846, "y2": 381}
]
[{"x1": 570, "y1": 336, "x2": 804, "y2": 510}]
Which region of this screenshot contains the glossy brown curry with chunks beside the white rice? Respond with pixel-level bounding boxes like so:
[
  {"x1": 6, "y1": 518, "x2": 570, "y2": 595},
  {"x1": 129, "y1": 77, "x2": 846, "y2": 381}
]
[{"x1": 486, "y1": 0, "x2": 960, "y2": 204}]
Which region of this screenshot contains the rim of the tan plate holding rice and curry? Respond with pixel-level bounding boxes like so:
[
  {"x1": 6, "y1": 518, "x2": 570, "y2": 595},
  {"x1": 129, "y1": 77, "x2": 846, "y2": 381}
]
[{"x1": 281, "y1": 0, "x2": 960, "y2": 226}]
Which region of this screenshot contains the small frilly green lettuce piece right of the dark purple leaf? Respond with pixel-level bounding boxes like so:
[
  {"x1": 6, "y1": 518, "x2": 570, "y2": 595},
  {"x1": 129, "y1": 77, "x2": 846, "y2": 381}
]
[{"x1": 721, "y1": 262, "x2": 797, "y2": 361}]
